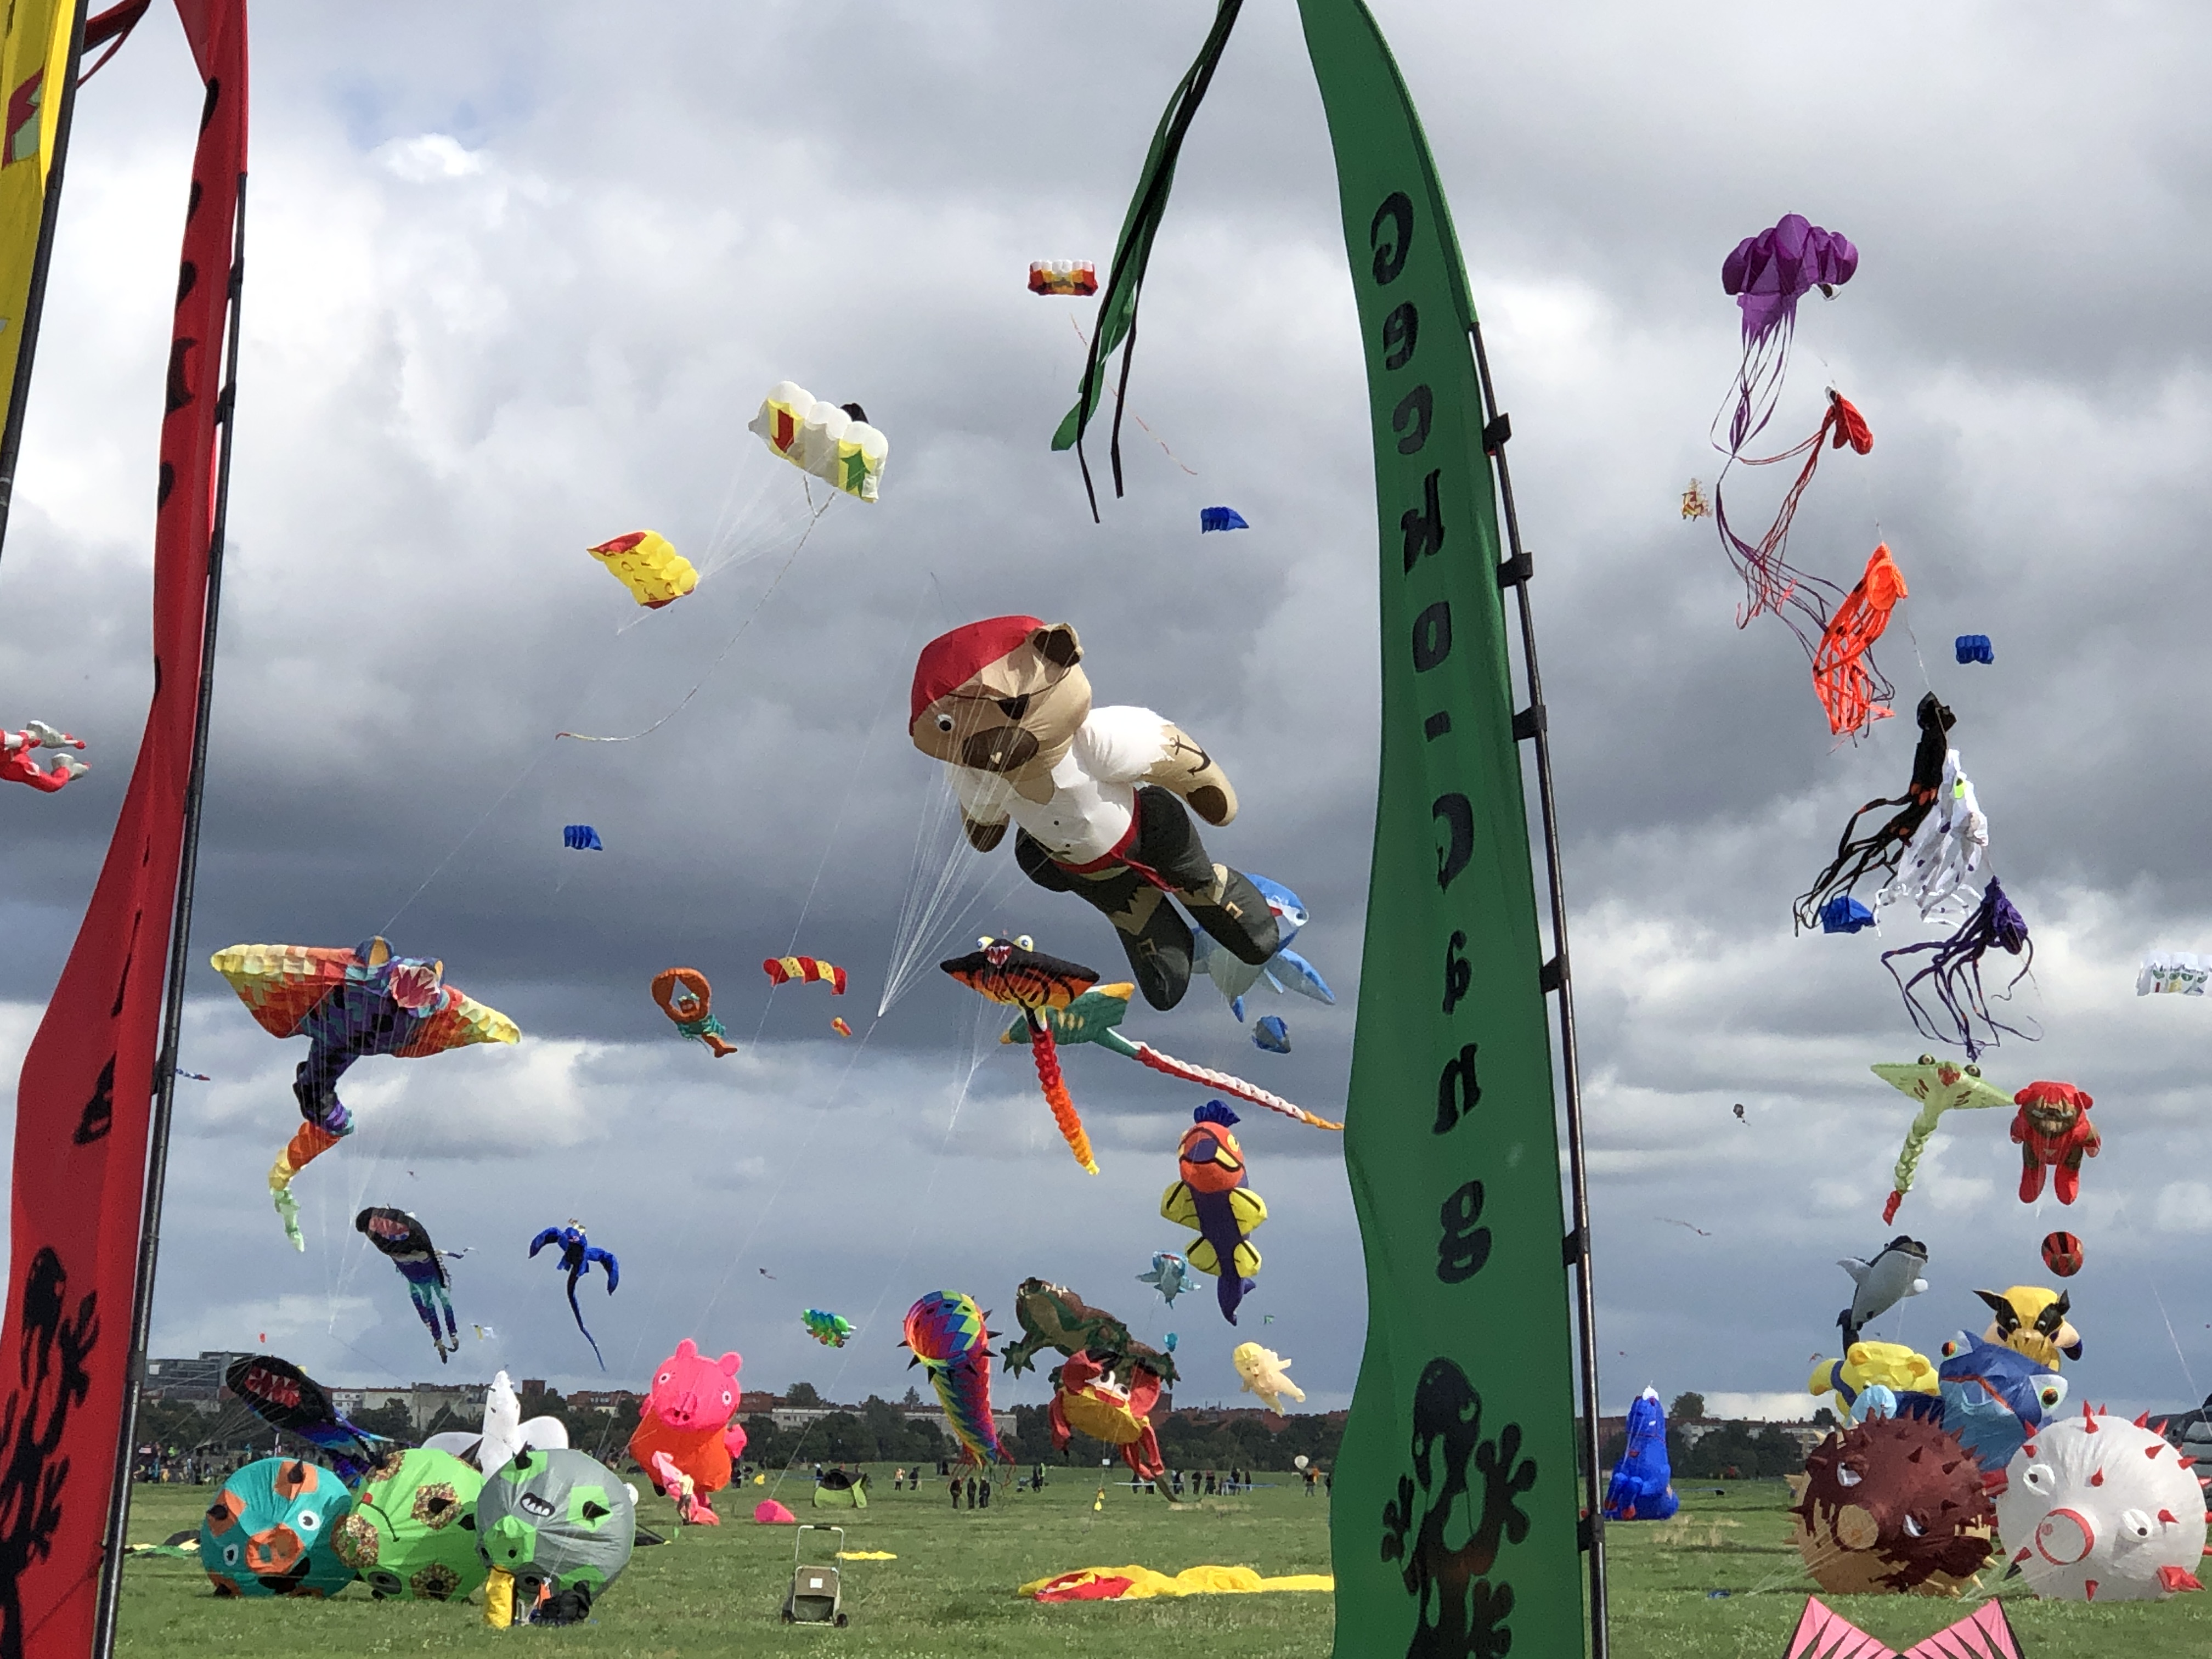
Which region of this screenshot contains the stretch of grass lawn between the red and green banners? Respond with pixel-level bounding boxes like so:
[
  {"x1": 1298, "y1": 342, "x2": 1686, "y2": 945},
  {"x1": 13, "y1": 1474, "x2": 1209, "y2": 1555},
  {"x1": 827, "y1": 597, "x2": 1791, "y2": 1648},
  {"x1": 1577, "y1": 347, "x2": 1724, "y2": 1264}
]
[{"x1": 117, "y1": 1466, "x2": 1336, "y2": 1659}]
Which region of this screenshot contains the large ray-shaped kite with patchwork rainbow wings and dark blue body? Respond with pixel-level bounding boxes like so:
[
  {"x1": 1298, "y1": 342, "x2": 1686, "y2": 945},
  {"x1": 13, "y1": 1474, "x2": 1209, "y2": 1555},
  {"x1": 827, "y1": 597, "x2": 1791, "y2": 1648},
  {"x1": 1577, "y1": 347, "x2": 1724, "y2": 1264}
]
[{"x1": 210, "y1": 938, "x2": 522, "y2": 1250}]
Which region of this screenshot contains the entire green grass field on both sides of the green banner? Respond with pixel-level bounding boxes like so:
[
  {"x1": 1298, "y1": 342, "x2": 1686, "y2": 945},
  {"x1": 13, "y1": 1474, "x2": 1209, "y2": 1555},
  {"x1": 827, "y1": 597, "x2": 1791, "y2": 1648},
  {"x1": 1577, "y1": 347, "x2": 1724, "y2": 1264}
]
[{"x1": 120, "y1": 1469, "x2": 2212, "y2": 1659}]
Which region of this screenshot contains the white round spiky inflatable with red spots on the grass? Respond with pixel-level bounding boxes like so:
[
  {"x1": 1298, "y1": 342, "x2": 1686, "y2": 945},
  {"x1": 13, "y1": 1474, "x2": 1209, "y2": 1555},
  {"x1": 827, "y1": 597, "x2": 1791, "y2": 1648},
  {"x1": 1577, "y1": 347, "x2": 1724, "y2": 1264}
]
[{"x1": 1997, "y1": 1404, "x2": 2205, "y2": 1601}]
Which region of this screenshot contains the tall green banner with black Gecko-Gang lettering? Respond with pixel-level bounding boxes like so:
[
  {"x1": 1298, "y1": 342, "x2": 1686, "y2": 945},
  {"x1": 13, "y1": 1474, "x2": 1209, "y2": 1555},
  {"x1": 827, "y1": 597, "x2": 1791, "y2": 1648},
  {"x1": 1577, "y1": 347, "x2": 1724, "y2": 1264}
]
[{"x1": 1299, "y1": 0, "x2": 1584, "y2": 1659}]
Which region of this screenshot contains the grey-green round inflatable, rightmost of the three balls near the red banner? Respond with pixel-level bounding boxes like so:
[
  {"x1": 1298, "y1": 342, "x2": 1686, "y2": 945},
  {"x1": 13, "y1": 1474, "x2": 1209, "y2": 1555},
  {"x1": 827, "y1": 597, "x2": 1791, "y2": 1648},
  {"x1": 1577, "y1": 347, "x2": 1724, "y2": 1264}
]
[{"x1": 476, "y1": 1447, "x2": 637, "y2": 1606}]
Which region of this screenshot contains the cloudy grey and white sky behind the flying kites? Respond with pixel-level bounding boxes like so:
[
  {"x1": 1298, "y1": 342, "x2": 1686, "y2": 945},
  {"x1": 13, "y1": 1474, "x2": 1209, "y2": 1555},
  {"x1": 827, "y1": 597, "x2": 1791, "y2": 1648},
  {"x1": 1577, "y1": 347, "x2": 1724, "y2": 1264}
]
[{"x1": 0, "y1": 0, "x2": 2212, "y2": 1413}]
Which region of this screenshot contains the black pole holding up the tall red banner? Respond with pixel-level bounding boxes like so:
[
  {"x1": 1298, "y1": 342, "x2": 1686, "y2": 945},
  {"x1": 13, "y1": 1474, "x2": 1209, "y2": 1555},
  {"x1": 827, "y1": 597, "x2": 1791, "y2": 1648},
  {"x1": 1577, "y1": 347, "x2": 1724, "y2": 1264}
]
[{"x1": 93, "y1": 177, "x2": 246, "y2": 1659}]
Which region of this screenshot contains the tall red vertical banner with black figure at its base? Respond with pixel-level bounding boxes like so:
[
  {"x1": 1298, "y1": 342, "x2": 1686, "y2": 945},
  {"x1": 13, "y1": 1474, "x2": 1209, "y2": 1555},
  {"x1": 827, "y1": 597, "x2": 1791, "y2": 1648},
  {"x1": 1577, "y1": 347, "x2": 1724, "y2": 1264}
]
[{"x1": 0, "y1": 0, "x2": 246, "y2": 1659}]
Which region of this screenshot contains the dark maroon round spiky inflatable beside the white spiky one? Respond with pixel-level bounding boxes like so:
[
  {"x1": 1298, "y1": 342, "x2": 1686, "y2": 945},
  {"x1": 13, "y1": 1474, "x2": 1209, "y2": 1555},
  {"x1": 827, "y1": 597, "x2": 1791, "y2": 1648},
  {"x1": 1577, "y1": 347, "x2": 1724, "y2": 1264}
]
[{"x1": 1790, "y1": 1415, "x2": 1995, "y2": 1595}]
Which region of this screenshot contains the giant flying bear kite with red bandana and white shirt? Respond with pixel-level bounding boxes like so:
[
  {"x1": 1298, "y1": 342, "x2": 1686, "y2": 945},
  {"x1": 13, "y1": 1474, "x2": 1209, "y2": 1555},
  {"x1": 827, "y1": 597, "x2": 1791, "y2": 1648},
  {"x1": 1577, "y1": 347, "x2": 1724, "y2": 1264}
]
[{"x1": 909, "y1": 617, "x2": 1278, "y2": 1009}]
